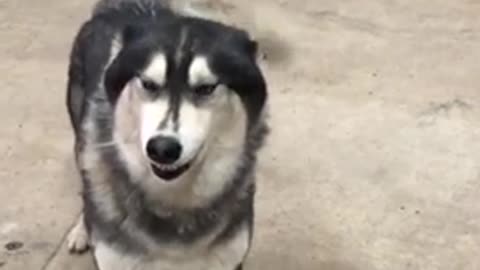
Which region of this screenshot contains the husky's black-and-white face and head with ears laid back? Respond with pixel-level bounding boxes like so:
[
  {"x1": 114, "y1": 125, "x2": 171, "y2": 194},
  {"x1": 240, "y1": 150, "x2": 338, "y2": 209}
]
[{"x1": 105, "y1": 19, "x2": 266, "y2": 186}]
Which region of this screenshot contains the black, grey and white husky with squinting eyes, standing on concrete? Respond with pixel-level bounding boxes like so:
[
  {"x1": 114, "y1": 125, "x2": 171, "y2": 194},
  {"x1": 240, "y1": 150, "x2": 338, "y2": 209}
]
[{"x1": 67, "y1": 0, "x2": 268, "y2": 270}]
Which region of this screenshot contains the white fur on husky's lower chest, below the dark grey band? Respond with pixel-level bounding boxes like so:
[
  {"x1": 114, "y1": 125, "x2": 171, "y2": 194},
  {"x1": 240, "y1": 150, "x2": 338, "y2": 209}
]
[{"x1": 94, "y1": 228, "x2": 249, "y2": 270}]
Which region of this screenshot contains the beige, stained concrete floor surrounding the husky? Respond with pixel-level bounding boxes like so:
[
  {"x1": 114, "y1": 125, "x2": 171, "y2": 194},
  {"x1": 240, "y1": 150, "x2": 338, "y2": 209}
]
[{"x1": 0, "y1": 0, "x2": 480, "y2": 270}]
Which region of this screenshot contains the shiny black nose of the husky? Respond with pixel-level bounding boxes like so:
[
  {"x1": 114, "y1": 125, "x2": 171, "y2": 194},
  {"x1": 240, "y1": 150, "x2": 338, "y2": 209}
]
[{"x1": 147, "y1": 136, "x2": 182, "y2": 164}]
